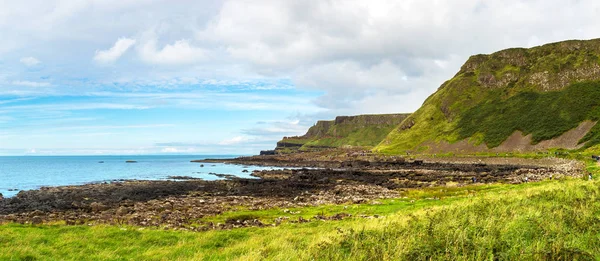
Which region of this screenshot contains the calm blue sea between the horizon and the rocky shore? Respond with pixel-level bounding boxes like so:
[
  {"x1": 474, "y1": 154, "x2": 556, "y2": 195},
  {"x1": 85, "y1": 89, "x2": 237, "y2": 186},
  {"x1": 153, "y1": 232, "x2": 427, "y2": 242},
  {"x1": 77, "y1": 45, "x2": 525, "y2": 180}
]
[{"x1": 0, "y1": 155, "x2": 272, "y2": 197}]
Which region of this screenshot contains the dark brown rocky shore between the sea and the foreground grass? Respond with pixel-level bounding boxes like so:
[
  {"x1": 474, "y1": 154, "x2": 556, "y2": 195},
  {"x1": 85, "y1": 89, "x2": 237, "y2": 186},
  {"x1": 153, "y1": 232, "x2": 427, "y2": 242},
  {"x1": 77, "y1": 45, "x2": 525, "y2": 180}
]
[{"x1": 0, "y1": 152, "x2": 583, "y2": 230}]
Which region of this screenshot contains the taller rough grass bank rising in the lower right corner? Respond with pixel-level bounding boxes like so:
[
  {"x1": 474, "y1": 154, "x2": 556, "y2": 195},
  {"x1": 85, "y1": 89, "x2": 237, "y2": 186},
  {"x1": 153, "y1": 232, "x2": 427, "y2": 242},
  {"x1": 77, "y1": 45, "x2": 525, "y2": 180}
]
[{"x1": 320, "y1": 181, "x2": 600, "y2": 260}]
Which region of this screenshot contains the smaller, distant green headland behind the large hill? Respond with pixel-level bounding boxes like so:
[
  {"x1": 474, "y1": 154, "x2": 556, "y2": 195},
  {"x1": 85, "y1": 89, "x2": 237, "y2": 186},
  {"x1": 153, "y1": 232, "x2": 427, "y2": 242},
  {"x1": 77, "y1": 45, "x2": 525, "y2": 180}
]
[{"x1": 275, "y1": 114, "x2": 409, "y2": 153}]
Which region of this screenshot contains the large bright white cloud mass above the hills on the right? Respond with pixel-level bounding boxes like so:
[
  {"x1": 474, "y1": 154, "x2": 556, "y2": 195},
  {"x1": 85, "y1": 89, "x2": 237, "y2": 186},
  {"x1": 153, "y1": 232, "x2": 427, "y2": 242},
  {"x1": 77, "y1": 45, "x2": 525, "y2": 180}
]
[{"x1": 197, "y1": 0, "x2": 600, "y2": 113}]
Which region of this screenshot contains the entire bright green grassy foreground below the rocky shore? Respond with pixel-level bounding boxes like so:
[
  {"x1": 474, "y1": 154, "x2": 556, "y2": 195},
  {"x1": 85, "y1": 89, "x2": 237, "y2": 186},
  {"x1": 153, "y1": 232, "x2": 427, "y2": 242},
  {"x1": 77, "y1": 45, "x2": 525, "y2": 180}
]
[{"x1": 0, "y1": 175, "x2": 600, "y2": 260}]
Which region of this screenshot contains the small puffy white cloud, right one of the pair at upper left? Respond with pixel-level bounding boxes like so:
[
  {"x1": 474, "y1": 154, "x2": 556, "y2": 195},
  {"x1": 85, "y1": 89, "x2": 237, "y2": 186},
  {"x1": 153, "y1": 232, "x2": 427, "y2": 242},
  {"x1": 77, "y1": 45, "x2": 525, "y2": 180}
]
[{"x1": 139, "y1": 39, "x2": 207, "y2": 65}]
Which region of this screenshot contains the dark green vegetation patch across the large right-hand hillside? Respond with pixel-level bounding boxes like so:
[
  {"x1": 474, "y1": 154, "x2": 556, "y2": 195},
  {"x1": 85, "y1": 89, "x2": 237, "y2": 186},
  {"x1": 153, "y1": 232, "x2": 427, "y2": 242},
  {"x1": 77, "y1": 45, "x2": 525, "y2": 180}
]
[{"x1": 456, "y1": 82, "x2": 600, "y2": 148}]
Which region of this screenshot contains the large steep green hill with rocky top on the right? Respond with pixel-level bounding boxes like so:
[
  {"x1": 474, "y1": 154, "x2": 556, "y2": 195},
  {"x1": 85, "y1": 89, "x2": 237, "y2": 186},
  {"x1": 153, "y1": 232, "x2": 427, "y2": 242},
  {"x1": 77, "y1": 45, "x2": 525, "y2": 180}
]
[{"x1": 375, "y1": 39, "x2": 600, "y2": 153}]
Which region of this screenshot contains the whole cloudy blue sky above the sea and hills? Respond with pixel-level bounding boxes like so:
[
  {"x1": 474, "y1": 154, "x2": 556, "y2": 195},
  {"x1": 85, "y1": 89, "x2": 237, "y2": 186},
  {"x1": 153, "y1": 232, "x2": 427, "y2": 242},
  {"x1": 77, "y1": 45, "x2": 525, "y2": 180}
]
[{"x1": 0, "y1": 0, "x2": 600, "y2": 155}]
